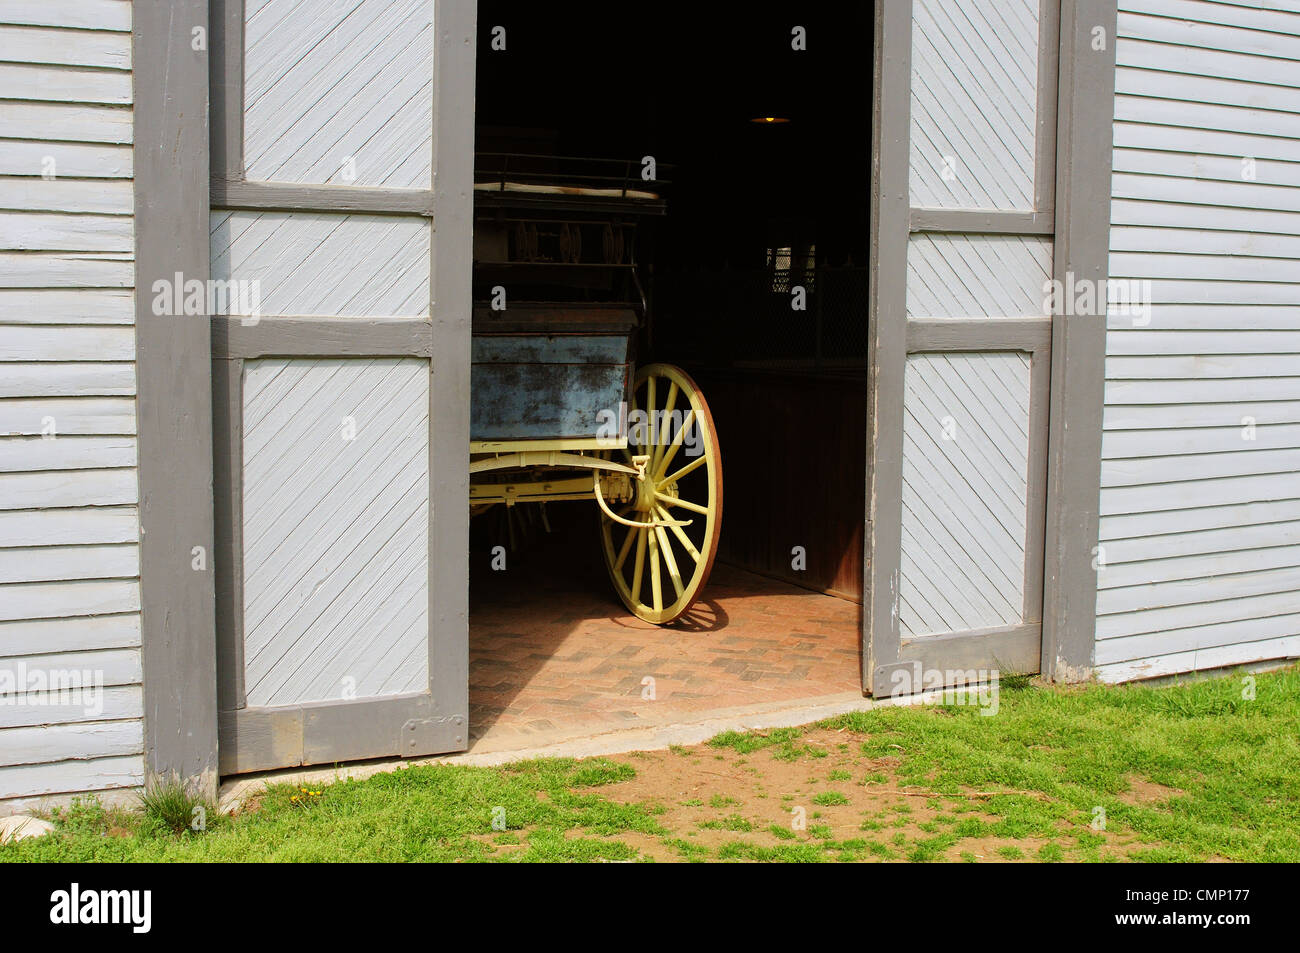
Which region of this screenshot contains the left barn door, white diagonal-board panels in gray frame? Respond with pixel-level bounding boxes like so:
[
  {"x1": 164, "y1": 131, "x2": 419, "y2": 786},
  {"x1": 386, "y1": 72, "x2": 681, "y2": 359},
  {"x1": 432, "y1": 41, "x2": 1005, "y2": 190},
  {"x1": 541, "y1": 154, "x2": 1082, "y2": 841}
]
[{"x1": 211, "y1": 0, "x2": 475, "y2": 774}]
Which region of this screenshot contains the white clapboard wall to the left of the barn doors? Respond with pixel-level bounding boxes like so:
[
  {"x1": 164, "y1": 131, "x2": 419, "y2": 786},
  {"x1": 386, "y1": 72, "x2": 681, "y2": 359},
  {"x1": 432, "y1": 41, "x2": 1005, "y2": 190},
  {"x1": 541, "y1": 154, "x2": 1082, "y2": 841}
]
[{"x1": 0, "y1": 0, "x2": 143, "y2": 814}]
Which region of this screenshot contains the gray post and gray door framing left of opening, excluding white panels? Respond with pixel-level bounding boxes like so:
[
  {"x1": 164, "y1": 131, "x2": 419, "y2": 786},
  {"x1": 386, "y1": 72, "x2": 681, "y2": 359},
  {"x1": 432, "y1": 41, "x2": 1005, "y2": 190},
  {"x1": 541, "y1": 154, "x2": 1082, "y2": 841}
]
[{"x1": 134, "y1": 0, "x2": 477, "y2": 797}]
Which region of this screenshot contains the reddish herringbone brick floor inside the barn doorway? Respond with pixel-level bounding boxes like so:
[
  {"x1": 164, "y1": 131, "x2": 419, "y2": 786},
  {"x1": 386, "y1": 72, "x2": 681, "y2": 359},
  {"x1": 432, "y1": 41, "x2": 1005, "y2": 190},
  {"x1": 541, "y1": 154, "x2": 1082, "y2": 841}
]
[{"x1": 469, "y1": 509, "x2": 861, "y2": 746}]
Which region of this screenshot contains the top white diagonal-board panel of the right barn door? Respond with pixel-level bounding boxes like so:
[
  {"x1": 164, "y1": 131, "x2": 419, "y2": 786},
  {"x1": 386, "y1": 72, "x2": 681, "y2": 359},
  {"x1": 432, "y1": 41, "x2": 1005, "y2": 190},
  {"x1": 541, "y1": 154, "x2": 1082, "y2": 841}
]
[{"x1": 910, "y1": 0, "x2": 1039, "y2": 209}]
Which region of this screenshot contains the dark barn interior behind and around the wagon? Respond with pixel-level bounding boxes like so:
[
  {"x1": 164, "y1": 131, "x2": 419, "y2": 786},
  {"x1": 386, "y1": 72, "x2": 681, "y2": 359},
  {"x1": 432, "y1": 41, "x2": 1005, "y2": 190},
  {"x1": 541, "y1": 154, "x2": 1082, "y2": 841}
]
[{"x1": 472, "y1": 0, "x2": 874, "y2": 743}]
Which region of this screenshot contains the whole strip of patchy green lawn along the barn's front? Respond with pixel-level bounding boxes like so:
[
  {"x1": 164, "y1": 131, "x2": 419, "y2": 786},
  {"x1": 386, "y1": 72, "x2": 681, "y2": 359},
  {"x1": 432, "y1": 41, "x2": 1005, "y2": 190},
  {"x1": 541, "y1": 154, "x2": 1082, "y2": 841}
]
[{"x1": 10, "y1": 667, "x2": 1300, "y2": 862}]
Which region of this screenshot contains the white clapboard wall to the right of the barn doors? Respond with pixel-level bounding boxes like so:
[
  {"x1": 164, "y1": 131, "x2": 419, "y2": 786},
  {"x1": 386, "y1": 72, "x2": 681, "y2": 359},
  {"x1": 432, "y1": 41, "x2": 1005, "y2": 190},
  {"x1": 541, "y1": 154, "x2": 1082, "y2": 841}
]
[{"x1": 1096, "y1": 0, "x2": 1300, "y2": 681}]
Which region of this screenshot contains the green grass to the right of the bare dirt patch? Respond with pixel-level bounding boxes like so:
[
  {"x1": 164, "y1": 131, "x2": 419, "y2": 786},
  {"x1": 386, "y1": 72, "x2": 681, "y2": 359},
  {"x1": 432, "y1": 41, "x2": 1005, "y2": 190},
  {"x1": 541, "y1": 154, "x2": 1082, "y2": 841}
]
[{"x1": 823, "y1": 667, "x2": 1300, "y2": 862}]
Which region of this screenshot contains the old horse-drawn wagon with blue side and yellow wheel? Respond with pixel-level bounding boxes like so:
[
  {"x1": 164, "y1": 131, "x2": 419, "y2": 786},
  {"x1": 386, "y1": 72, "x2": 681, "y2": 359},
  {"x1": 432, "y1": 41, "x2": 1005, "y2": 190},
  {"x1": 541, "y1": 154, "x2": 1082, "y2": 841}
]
[{"x1": 469, "y1": 153, "x2": 723, "y2": 624}]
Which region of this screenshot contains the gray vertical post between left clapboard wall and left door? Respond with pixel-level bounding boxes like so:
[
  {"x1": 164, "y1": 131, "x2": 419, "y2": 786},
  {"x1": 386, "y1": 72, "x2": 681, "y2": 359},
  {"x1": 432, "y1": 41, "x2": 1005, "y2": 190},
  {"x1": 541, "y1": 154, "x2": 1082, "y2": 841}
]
[{"x1": 133, "y1": 0, "x2": 217, "y2": 797}]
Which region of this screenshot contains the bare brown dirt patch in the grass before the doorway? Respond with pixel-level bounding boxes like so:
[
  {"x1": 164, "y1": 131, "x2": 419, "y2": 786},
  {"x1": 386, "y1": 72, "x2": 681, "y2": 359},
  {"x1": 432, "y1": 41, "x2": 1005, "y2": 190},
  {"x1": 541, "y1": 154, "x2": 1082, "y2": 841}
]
[{"x1": 574, "y1": 729, "x2": 1123, "y2": 862}]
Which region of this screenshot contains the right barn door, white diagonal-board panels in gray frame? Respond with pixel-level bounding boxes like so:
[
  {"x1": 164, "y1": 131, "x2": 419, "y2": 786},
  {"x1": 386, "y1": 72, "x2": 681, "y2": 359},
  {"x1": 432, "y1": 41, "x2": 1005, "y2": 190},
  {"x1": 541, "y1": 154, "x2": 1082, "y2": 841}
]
[{"x1": 863, "y1": 0, "x2": 1060, "y2": 696}]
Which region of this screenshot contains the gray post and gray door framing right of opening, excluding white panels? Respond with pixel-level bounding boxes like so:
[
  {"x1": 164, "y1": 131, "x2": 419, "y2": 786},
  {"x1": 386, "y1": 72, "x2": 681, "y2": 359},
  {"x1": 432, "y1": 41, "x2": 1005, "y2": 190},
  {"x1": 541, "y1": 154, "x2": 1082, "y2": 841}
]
[{"x1": 862, "y1": 0, "x2": 1117, "y2": 694}]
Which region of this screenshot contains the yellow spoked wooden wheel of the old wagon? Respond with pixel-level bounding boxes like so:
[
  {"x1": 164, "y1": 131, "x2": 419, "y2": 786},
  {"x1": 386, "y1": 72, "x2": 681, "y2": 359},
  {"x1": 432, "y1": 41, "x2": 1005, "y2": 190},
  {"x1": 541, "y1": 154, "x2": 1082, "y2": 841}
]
[{"x1": 601, "y1": 364, "x2": 723, "y2": 625}]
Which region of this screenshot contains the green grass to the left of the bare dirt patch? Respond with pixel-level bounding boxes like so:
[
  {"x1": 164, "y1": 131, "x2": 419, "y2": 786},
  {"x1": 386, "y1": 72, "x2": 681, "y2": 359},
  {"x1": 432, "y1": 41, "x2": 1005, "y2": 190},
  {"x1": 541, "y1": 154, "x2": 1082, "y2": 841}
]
[{"x1": 0, "y1": 758, "x2": 667, "y2": 862}]
